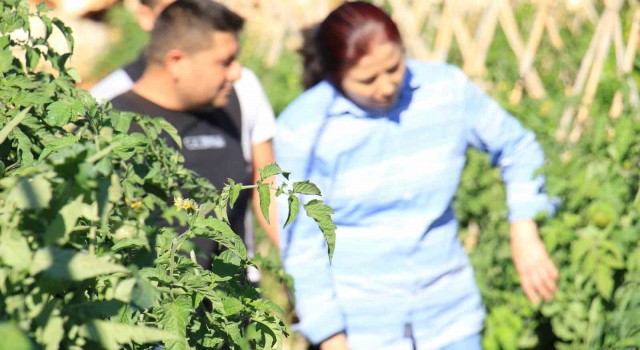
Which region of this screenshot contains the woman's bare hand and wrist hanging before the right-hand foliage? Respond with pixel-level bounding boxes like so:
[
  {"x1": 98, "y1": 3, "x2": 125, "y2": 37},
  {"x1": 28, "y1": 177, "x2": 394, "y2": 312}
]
[{"x1": 511, "y1": 220, "x2": 558, "y2": 304}]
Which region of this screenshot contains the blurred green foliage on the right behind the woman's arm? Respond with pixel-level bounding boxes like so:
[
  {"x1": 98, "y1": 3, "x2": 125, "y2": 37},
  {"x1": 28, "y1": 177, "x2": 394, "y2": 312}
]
[{"x1": 454, "y1": 4, "x2": 640, "y2": 349}]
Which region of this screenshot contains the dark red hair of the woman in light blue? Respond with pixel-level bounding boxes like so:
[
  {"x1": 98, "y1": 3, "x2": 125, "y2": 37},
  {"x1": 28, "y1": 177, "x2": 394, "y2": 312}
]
[{"x1": 315, "y1": 1, "x2": 402, "y2": 88}]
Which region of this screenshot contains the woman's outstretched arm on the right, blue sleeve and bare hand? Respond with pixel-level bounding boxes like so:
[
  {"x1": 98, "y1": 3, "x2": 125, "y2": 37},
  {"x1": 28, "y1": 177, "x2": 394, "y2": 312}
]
[{"x1": 464, "y1": 69, "x2": 558, "y2": 303}]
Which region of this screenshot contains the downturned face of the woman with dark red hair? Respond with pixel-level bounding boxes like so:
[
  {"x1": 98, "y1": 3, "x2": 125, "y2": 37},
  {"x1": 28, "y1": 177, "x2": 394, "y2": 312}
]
[{"x1": 342, "y1": 40, "x2": 405, "y2": 111}]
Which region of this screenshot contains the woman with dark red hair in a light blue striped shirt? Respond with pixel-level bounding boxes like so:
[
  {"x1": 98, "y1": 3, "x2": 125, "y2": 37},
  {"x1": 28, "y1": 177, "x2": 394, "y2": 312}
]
[{"x1": 275, "y1": 2, "x2": 558, "y2": 350}]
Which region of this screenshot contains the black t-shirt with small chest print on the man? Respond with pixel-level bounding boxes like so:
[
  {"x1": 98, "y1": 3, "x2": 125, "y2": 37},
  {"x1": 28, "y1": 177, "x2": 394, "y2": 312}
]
[{"x1": 111, "y1": 91, "x2": 252, "y2": 265}]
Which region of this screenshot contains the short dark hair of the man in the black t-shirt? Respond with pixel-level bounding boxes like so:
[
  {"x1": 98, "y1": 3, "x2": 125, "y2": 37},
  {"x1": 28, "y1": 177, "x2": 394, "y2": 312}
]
[{"x1": 145, "y1": 0, "x2": 244, "y2": 63}]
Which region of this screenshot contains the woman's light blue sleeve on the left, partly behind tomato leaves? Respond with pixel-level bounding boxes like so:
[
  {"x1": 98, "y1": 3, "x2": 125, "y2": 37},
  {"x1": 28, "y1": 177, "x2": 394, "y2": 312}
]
[{"x1": 274, "y1": 89, "x2": 345, "y2": 344}]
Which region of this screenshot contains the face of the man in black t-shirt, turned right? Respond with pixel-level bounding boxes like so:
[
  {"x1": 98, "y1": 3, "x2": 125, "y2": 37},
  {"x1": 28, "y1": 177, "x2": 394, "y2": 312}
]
[{"x1": 174, "y1": 32, "x2": 242, "y2": 109}]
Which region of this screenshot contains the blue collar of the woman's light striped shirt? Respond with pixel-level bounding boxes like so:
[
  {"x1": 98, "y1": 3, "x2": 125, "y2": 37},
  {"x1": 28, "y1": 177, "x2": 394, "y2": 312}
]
[{"x1": 328, "y1": 65, "x2": 420, "y2": 118}]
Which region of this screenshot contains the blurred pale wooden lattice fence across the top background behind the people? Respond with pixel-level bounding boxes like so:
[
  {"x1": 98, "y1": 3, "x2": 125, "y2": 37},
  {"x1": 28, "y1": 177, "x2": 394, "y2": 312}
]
[{"x1": 218, "y1": 0, "x2": 640, "y2": 142}]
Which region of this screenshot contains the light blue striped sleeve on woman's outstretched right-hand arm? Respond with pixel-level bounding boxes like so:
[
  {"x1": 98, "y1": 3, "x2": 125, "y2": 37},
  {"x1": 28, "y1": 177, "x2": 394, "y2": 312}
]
[{"x1": 463, "y1": 72, "x2": 553, "y2": 221}]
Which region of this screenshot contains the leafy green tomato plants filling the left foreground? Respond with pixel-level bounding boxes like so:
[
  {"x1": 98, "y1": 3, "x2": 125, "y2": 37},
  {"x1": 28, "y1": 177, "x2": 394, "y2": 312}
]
[{"x1": 0, "y1": 0, "x2": 333, "y2": 349}]
